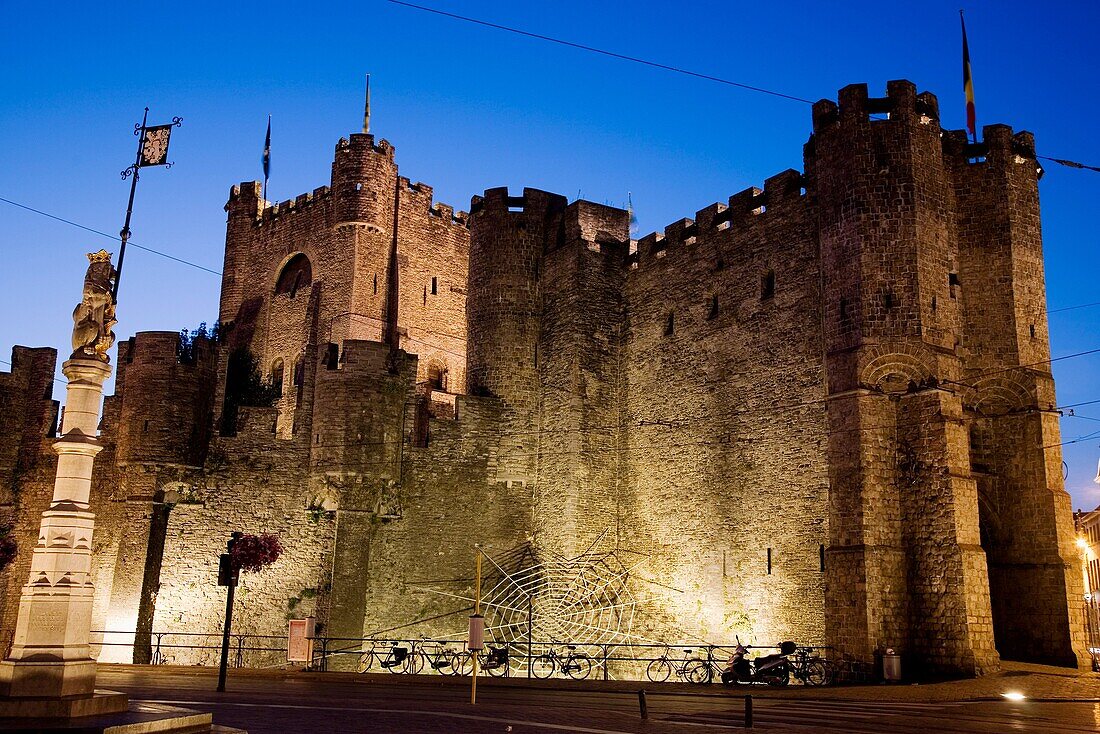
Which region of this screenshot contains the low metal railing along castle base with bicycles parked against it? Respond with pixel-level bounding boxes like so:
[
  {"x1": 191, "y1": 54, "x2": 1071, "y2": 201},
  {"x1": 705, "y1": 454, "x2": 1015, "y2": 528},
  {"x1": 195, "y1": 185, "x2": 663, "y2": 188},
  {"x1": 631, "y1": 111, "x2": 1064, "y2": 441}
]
[{"x1": 92, "y1": 631, "x2": 878, "y2": 683}]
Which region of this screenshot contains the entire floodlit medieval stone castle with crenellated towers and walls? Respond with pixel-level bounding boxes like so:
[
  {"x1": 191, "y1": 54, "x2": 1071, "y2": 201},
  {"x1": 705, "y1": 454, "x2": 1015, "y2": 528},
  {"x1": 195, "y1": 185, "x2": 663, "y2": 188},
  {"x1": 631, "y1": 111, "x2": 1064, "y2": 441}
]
[{"x1": 0, "y1": 81, "x2": 1087, "y2": 673}]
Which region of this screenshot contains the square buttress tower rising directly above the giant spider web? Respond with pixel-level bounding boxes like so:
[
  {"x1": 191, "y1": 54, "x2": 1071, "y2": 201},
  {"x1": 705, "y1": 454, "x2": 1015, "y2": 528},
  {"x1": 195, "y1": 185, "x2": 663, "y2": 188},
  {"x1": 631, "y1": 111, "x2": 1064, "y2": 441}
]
[{"x1": 534, "y1": 201, "x2": 630, "y2": 558}]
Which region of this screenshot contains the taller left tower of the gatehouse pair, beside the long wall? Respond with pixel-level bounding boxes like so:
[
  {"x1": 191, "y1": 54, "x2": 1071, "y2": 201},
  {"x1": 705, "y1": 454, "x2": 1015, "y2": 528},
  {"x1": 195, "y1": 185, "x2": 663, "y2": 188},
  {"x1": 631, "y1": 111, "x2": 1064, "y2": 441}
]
[{"x1": 806, "y1": 81, "x2": 999, "y2": 672}]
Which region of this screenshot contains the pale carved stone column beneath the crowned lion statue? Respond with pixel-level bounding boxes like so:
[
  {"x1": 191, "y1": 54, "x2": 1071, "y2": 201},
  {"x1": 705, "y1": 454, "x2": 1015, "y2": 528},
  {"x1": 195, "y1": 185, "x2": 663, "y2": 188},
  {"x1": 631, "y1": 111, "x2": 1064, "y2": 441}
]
[{"x1": 0, "y1": 355, "x2": 111, "y2": 698}]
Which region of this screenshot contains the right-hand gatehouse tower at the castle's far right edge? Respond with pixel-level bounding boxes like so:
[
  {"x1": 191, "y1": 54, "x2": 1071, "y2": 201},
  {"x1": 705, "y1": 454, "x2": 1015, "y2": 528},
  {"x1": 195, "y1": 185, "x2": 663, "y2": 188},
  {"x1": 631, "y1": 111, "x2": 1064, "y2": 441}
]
[{"x1": 945, "y1": 125, "x2": 1089, "y2": 666}]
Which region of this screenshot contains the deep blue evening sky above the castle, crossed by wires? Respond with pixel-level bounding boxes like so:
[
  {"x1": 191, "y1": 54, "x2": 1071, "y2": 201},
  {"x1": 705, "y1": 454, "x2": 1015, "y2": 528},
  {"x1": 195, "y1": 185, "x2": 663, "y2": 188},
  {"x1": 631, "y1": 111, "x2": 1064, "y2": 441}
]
[{"x1": 0, "y1": 0, "x2": 1100, "y2": 507}]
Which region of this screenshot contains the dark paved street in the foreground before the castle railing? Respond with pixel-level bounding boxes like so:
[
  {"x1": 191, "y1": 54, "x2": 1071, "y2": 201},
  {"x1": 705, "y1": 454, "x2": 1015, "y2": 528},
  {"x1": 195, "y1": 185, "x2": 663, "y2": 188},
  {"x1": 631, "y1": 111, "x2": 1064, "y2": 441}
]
[{"x1": 99, "y1": 666, "x2": 1100, "y2": 734}]
